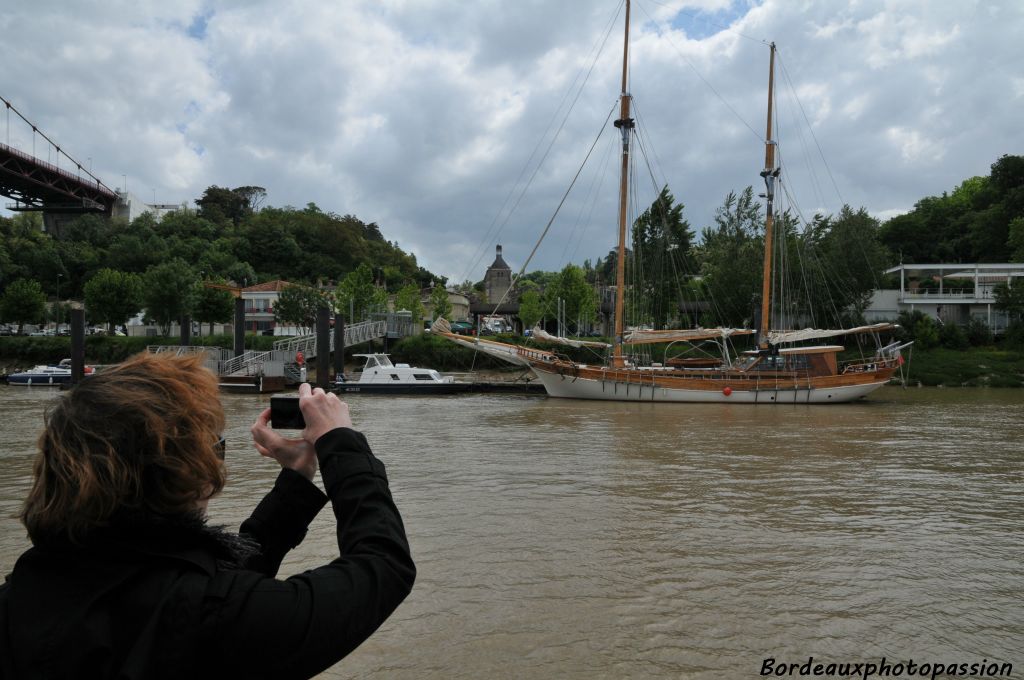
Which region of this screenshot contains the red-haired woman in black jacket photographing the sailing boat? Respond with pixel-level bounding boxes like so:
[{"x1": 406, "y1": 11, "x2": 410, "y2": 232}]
[{"x1": 0, "y1": 354, "x2": 416, "y2": 678}]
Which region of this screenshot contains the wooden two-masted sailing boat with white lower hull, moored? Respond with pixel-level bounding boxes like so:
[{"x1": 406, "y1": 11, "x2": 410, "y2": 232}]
[{"x1": 432, "y1": 0, "x2": 905, "y2": 403}]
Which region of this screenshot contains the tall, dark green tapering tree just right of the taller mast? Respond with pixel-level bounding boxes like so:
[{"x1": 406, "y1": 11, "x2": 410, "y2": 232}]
[{"x1": 630, "y1": 186, "x2": 692, "y2": 329}]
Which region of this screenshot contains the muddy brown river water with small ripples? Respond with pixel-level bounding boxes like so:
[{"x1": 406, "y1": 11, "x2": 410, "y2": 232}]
[{"x1": 0, "y1": 386, "x2": 1024, "y2": 680}]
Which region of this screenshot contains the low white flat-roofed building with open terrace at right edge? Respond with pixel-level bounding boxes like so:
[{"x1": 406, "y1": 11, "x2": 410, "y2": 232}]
[{"x1": 864, "y1": 262, "x2": 1024, "y2": 331}]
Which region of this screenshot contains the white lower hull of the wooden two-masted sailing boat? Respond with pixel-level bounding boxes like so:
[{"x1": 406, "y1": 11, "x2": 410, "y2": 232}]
[{"x1": 534, "y1": 367, "x2": 886, "y2": 403}]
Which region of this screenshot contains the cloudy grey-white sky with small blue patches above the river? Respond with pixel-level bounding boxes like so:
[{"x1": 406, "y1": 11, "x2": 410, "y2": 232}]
[{"x1": 0, "y1": 0, "x2": 1024, "y2": 281}]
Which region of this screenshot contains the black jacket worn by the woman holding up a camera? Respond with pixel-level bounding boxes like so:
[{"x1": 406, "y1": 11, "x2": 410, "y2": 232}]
[{"x1": 0, "y1": 428, "x2": 416, "y2": 678}]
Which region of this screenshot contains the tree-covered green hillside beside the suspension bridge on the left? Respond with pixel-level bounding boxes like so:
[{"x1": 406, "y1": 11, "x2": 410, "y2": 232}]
[{"x1": 0, "y1": 186, "x2": 440, "y2": 311}]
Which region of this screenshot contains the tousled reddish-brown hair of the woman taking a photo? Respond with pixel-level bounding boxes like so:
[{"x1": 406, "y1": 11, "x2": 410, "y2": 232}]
[{"x1": 22, "y1": 353, "x2": 225, "y2": 543}]
